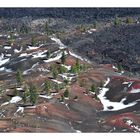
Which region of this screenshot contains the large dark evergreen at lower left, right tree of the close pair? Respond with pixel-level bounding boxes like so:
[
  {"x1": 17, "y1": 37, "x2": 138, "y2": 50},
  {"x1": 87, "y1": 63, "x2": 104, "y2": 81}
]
[{"x1": 30, "y1": 85, "x2": 38, "y2": 105}]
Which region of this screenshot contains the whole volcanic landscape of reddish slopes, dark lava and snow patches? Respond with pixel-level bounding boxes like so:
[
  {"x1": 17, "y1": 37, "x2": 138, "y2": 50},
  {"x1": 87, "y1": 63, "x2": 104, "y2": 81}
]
[{"x1": 0, "y1": 8, "x2": 140, "y2": 133}]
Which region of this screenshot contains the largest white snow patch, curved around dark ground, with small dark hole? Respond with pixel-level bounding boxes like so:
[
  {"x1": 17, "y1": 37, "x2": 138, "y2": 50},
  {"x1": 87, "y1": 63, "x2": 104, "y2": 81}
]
[{"x1": 98, "y1": 88, "x2": 137, "y2": 111}]
